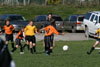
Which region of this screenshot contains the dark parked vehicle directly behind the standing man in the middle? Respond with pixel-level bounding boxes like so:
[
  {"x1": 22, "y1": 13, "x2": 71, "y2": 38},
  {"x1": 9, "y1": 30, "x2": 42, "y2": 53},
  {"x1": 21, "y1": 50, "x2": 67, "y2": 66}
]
[{"x1": 34, "y1": 15, "x2": 63, "y2": 30}]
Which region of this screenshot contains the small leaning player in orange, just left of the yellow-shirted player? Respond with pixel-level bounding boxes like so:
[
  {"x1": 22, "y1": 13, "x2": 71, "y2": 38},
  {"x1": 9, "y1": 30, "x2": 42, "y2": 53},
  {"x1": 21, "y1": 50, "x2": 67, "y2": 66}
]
[{"x1": 11, "y1": 27, "x2": 24, "y2": 54}]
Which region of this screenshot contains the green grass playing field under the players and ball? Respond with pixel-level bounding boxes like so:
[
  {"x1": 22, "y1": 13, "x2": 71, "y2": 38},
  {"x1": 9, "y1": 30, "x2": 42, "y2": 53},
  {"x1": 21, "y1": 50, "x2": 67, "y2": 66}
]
[{"x1": 8, "y1": 40, "x2": 100, "y2": 67}]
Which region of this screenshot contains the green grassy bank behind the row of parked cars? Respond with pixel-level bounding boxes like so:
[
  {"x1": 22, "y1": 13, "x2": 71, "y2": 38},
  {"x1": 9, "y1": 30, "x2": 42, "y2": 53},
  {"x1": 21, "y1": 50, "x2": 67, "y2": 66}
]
[{"x1": 0, "y1": 5, "x2": 100, "y2": 20}]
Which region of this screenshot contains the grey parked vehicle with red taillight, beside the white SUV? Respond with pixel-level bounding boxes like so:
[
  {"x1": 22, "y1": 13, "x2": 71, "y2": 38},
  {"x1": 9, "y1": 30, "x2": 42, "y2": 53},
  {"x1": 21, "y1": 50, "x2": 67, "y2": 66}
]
[{"x1": 64, "y1": 15, "x2": 84, "y2": 33}]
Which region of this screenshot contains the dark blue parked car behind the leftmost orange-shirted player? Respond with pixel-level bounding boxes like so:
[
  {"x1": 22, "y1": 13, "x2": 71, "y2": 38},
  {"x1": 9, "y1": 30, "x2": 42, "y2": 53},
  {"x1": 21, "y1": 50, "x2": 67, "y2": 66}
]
[{"x1": 0, "y1": 14, "x2": 28, "y2": 31}]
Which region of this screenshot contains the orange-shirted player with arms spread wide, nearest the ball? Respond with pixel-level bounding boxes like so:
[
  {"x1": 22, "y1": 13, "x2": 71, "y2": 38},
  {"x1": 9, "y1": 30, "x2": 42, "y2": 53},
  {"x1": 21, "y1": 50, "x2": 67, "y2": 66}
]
[{"x1": 39, "y1": 21, "x2": 64, "y2": 55}]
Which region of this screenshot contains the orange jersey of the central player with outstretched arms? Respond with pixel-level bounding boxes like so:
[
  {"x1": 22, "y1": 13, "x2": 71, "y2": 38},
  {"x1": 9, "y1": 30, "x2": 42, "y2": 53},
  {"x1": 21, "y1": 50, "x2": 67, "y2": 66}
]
[{"x1": 43, "y1": 25, "x2": 59, "y2": 36}]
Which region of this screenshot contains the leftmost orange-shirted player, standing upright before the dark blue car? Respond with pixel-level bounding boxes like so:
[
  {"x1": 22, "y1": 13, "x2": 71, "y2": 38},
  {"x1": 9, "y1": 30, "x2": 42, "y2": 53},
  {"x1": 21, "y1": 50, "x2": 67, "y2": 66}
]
[{"x1": 3, "y1": 20, "x2": 15, "y2": 48}]
